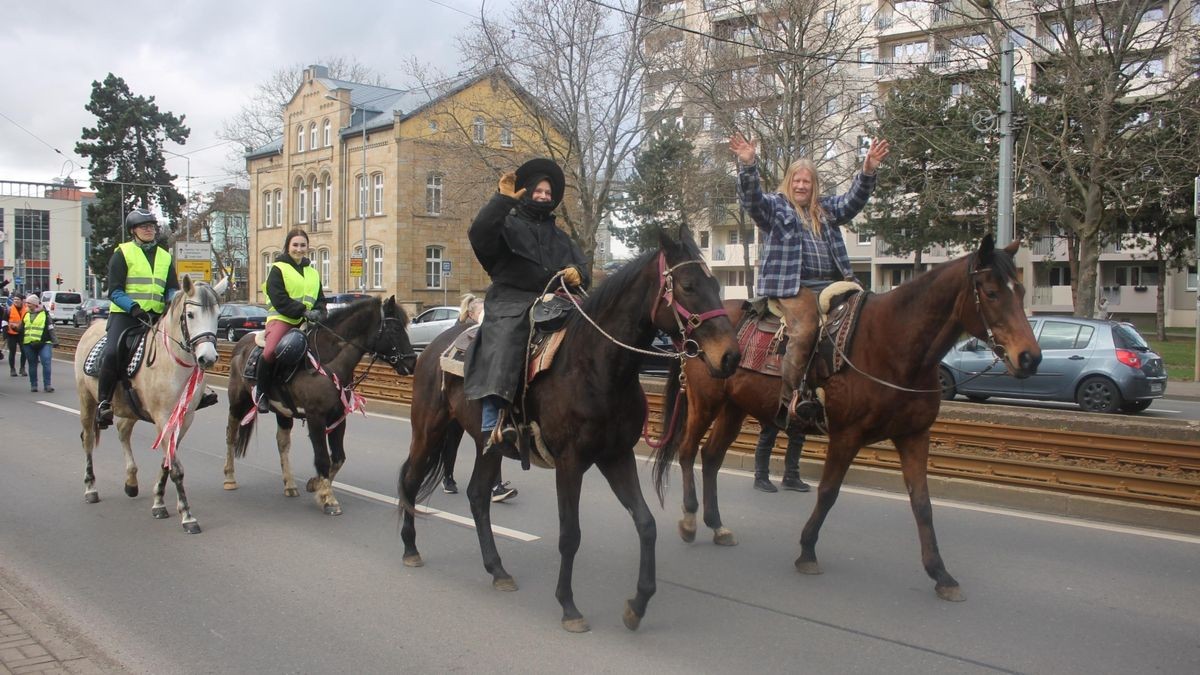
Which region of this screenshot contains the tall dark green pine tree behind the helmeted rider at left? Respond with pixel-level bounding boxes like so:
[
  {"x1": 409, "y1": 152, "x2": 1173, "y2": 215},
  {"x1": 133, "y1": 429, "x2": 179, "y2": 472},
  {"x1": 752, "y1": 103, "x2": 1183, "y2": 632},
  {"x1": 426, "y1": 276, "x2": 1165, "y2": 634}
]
[{"x1": 76, "y1": 73, "x2": 191, "y2": 281}]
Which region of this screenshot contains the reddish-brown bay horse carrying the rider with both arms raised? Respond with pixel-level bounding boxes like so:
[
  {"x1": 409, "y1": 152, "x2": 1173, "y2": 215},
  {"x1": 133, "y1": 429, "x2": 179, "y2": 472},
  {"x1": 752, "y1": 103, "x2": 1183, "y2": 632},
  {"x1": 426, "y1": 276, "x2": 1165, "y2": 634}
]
[{"x1": 654, "y1": 234, "x2": 1042, "y2": 601}]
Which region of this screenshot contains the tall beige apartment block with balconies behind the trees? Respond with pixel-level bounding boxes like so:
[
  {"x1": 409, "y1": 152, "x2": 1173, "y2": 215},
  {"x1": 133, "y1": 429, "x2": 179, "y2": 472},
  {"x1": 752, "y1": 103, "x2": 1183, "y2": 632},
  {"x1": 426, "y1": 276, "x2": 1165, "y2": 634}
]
[{"x1": 643, "y1": 0, "x2": 1200, "y2": 327}]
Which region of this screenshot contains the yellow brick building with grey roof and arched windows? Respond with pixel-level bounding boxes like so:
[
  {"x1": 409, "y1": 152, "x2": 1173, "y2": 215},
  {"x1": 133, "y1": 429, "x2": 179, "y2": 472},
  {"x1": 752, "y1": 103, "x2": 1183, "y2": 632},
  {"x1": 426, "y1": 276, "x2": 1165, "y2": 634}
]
[{"x1": 246, "y1": 66, "x2": 561, "y2": 311}]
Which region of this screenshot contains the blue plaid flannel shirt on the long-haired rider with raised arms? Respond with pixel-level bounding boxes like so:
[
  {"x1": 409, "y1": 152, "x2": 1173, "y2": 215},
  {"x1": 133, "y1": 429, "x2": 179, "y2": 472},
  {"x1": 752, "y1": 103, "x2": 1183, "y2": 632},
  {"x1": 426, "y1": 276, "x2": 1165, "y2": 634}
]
[{"x1": 738, "y1": 159, "x2": 875, "y2": 298}]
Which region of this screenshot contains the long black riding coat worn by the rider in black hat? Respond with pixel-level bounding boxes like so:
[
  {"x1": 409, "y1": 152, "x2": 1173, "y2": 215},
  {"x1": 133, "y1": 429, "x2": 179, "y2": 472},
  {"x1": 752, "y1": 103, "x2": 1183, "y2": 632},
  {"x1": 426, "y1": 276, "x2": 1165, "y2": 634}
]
[{"x1": 466, "y1": 189, "x2": 592, "y2": 402}]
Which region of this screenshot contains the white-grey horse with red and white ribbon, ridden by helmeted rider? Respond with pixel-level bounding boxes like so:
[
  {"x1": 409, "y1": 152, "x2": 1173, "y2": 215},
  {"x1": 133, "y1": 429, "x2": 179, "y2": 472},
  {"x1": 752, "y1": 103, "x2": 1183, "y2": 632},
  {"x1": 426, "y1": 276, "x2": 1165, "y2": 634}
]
[{"x1": 74, "y1": 275, "x2": 226, "y2": 534}]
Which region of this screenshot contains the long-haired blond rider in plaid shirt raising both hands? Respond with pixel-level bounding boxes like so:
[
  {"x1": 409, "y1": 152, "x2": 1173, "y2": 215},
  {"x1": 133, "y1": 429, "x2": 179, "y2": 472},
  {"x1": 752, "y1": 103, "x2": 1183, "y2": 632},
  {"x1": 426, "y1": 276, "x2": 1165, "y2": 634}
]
[{"x1": 730, "y1": 133, "x2": 888, "y2": 426}]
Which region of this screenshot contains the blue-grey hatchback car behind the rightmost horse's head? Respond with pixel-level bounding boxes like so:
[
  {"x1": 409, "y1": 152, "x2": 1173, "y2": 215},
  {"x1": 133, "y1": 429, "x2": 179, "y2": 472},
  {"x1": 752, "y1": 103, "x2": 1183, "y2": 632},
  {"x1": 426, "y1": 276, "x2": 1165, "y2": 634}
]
[{"x1": 938, "y1": 316, "x2": 1166, "y2": 412}]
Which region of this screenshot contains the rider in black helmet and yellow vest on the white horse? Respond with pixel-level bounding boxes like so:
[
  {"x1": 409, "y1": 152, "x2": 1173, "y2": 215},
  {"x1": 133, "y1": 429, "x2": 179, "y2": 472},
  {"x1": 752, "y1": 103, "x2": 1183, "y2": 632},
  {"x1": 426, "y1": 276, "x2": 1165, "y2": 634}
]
[{"x1": 96, "y1": 209, "x2": 179, "y2": 429}]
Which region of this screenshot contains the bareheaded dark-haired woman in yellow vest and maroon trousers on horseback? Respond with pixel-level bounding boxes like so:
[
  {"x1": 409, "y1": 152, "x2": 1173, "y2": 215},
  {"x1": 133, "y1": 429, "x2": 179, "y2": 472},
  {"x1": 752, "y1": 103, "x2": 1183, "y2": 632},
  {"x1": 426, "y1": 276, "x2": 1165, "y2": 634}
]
[{"x1": 258, "y1": 227, "x2": 325, "y2": 413}]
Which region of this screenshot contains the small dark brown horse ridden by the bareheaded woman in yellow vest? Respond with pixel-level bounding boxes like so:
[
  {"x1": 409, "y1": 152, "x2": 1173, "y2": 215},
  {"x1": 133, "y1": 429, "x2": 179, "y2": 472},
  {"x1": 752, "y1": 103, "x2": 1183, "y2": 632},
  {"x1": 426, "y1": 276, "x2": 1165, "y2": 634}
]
[{"x1": 224, "y1": 295, "x2": 416, "y2": 515}]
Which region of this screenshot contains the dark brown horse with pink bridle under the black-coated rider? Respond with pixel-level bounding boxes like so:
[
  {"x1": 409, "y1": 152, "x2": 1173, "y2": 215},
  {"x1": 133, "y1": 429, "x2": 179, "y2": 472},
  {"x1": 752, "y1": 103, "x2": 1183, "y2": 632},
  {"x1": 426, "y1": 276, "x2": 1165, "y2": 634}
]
[{"x1": 398, "y1": 233, "x2": 740, "y2": 633}]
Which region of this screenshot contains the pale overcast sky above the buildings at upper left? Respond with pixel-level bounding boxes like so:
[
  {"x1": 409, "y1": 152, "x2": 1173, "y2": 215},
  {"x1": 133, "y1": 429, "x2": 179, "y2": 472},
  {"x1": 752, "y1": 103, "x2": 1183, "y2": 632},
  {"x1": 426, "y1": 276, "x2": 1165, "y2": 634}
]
[{"x1": 0, "y1": 0, "x2": 512, "y2": 191}]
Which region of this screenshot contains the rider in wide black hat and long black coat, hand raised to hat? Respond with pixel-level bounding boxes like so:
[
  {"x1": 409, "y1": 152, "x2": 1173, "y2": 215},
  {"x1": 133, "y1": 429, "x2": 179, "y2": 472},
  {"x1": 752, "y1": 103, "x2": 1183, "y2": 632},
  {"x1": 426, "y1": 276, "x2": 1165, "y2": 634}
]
[{"x1": 466, "y1": 159, "x2": 590, "y2": 492}]
